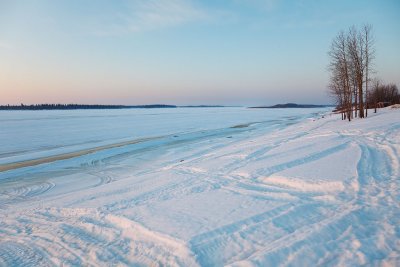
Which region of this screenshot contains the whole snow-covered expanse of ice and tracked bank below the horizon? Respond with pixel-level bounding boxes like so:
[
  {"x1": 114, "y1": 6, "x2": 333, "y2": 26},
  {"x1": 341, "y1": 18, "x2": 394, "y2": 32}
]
[{"x1": 0, "y1": 108, "x2": 400, "y2": 266}]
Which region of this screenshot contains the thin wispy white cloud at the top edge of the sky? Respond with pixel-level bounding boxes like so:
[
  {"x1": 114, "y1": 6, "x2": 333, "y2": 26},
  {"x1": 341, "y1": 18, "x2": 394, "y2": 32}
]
[{"x1": 94, "y1": 0, "x2": 209, "y2": 35}]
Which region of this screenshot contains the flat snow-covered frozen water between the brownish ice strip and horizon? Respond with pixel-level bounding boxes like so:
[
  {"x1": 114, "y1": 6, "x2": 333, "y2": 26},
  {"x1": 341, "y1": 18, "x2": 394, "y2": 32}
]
[{"x1": 0, "y1": 108, "x2": 319, "y2": 164}]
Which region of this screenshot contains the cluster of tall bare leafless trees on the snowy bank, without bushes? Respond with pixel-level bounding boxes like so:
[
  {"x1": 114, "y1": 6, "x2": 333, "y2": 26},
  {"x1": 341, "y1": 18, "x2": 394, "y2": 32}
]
[{"x1": 328, "y1": 24, "x2": 375, "y2": 121}]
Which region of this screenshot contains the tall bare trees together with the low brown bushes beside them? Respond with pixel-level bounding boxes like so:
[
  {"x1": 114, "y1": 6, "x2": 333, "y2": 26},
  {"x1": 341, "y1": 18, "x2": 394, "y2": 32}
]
[{"x1": 328, "y1": 24, "x2": 399, "y2": 121}]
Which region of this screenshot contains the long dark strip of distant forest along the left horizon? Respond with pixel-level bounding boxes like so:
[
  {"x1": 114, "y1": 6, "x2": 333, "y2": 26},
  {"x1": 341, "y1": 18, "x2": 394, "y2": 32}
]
[{"x1": 0, "y1": 104, "x2": 177, "y2": 110}]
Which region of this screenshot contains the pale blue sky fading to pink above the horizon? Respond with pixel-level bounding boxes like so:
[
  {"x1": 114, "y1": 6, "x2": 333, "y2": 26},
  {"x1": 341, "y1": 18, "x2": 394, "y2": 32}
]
[{"x1": 0, "y1": 0, "x2": 400, "y2": 105}]
